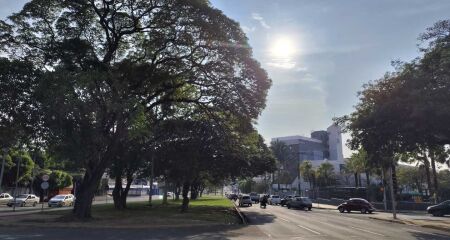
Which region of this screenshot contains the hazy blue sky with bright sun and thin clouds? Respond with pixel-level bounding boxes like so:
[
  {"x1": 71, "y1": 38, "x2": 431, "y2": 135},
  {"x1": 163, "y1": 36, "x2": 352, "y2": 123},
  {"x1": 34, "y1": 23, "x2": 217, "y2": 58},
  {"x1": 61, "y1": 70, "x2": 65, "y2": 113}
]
[{"x1": 0, "y1": 0, "x2": 450, "y2": 157}]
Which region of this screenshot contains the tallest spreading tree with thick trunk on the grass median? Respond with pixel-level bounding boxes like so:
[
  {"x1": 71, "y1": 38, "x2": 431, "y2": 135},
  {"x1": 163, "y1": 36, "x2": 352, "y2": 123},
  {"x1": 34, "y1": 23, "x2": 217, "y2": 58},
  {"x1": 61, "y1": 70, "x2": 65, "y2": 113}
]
[{"x1": 0, "y1": 0, "x2": 270, "y2": 218}]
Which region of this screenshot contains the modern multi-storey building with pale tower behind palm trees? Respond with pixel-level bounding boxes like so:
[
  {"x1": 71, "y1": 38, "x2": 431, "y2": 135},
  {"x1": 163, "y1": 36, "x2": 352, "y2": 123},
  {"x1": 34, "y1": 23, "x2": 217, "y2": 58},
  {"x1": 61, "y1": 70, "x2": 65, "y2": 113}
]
[{"x1": 272, "y1": 124, "x2": 345, "y2": 193}]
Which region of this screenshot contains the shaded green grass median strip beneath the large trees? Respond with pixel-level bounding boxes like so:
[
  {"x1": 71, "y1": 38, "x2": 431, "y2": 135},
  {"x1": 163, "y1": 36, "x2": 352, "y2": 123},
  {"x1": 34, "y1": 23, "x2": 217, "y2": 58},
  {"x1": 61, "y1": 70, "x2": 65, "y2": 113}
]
[{"x1": 3, "y1": 196, "x2": 240, "y2": 228}]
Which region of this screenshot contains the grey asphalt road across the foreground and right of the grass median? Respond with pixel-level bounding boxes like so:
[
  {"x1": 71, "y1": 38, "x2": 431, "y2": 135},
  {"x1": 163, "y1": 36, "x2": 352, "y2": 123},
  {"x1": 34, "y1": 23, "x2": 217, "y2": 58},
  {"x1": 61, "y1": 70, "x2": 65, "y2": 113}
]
[{"x1": 0, "y1": 204, "x2": 450, "y2": 240}]
